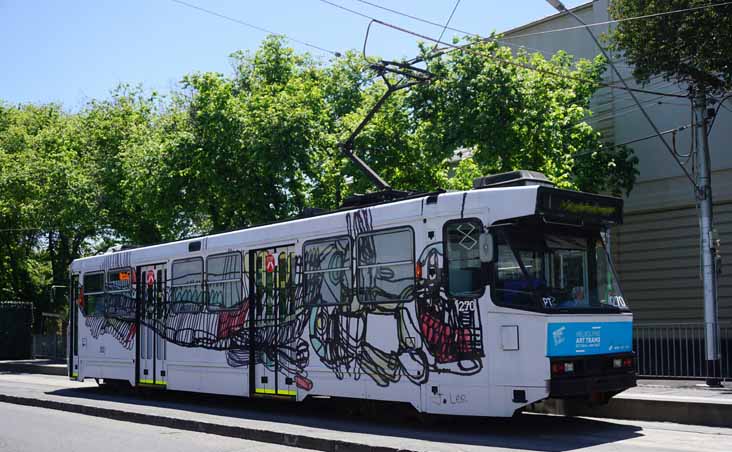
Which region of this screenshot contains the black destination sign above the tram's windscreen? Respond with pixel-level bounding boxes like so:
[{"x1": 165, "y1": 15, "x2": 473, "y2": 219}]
[{"x1": 536, "y1": 187, "x2": 623, "y2": 224}]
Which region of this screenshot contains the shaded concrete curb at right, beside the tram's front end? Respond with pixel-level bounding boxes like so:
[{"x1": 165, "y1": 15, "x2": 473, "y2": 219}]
[{"x1": 535, "y1": 397, "x2": 732, "y2": 427}]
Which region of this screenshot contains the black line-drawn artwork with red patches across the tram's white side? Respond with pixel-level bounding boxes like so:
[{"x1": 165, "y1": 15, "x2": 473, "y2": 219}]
[{"x1": 78, "y1": 209, "x2": 484, "y2": 390}]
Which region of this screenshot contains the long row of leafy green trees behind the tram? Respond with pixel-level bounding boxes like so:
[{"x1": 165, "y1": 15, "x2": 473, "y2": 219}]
[{"x1": 0, "y1": 37, "x2": 636, "y2": 322}]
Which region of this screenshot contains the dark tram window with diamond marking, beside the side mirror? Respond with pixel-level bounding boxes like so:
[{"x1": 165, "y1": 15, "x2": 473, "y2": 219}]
[{"x1": 445, "y1": 220, "x2": 485, "y2": 298}]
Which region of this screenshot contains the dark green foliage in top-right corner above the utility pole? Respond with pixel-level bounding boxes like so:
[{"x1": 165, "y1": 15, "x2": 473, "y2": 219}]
[{"x1": 609, "y1": 0, "x2": 732, "y2": 93}]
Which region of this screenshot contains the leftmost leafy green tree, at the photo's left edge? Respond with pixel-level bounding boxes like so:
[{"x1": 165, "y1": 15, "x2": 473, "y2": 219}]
[{"x1": 0, "y1": 105, "x2": 99, "y2": 322}]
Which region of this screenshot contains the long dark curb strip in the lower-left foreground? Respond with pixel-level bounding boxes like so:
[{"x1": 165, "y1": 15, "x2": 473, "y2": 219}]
[{"x1": 0, "y1": 394, "x2": 417, "y2": 452}]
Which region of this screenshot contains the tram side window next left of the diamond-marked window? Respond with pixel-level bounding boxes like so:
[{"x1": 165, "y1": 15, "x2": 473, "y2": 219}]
[{"x1": 356, "y1": 228, "x2": 414, "y2": 303}]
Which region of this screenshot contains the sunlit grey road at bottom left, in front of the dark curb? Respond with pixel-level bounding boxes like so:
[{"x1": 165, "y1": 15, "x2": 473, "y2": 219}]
[{"x1": 0, "y1": 403, "x2": 303, "y2": 452}]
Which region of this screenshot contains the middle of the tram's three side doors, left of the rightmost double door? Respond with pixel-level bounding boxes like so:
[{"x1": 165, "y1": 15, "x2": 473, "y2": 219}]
[{"x1": 135, "y1": 264, "x2": 167, "y2": 386}]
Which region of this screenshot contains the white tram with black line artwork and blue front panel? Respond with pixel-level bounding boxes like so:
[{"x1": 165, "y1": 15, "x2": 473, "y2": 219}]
[{"x1": 69, "y1": 172, "x2": 635, "y2": 416}]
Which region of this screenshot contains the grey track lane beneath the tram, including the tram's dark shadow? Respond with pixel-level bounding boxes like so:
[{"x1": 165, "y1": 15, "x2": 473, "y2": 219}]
[{"x1": 0, "y1": 374, "x2": 732, "y2": 452}]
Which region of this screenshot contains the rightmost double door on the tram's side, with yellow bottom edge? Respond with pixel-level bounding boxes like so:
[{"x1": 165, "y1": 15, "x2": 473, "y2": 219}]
[{"x1": 249, "y1": 246, "x2": 297, "y2": 397}]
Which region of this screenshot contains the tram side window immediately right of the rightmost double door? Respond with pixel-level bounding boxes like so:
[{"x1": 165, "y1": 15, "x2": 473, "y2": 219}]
[{"x1": 303, "y1": 236, "x2": 353, "y2": 305}]
